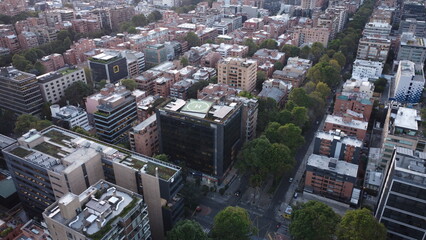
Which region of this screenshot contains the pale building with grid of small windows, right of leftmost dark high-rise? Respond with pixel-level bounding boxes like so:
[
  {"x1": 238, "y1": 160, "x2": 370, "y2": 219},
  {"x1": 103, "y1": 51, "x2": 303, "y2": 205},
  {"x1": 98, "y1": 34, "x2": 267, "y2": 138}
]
[{"x1": 37, "y1": 67, "x2": 87, "y2": 103}]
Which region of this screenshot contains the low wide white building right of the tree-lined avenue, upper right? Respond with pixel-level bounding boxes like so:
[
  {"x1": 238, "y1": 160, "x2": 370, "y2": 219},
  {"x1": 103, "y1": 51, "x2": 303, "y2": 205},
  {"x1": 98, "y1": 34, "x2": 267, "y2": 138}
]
[{"x1": 352, "y1": 59, "x2": 383, "y2": 79}]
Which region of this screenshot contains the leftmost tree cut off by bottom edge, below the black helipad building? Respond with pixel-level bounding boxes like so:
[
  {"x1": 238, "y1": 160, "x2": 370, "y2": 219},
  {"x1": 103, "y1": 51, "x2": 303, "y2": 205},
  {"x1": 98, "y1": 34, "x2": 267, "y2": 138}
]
[{"x1": 167, "y1": 220, "x2": 208, "y2": 240}]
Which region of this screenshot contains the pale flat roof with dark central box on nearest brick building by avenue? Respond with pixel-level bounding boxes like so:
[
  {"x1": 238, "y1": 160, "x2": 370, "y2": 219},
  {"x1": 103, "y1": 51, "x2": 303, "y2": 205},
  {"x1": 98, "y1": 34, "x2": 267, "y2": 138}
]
[{"x1": 307, "y1": 154, "x2": 358, "y2": 178}]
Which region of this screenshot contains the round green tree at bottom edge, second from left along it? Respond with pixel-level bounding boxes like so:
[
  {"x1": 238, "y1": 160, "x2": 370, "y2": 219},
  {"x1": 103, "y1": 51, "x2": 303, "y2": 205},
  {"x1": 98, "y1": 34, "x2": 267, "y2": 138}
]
[{"x1": 212, "y1": 207, "x2": 257, "y2": 240}]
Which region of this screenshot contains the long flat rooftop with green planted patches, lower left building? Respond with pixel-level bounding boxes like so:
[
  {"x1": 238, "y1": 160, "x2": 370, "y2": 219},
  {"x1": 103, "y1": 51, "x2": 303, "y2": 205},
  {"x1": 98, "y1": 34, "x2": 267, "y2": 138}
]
[{"x1": 5, "y1": 126, "x2": 180, "y2": 181}]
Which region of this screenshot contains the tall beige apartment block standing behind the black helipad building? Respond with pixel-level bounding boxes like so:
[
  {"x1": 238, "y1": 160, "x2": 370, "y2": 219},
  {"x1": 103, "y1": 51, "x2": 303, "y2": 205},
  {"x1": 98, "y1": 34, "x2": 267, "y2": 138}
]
[{"x1": 217, "y1": 58, "x2": 257, "y2": 92}]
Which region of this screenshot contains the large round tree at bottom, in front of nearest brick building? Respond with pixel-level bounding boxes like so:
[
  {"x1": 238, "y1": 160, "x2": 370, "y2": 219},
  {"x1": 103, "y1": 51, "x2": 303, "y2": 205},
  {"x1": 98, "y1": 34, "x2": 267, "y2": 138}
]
[{"x1": 289, "y1": 201, "x2": 340, "y2": 240}]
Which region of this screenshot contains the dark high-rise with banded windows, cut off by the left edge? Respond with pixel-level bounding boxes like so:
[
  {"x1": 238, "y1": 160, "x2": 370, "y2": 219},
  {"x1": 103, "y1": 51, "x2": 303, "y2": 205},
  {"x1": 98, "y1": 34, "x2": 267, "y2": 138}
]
[{"x1": 0, "y1": 67, "x2": 43, "y2": 114}]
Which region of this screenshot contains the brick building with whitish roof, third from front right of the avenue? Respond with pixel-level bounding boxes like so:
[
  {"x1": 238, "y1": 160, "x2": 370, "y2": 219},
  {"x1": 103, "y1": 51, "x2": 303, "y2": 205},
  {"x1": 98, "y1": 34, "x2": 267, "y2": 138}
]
[{"x1": 323, "y1": 115, "x2": 368, "y2": 141}]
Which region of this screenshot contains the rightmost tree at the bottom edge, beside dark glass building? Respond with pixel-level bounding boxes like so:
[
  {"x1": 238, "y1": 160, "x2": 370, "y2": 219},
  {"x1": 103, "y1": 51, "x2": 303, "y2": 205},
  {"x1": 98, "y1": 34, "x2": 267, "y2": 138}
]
[{"x1": 336, "y1": 208, "x2": 386, "y2": 240}]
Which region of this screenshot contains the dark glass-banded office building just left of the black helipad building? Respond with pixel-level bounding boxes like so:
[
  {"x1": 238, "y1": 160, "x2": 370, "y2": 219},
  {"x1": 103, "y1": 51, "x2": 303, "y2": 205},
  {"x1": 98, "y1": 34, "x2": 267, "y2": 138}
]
[{"x1": 93, "y1": 87, "x2": 137, "y2": 144}]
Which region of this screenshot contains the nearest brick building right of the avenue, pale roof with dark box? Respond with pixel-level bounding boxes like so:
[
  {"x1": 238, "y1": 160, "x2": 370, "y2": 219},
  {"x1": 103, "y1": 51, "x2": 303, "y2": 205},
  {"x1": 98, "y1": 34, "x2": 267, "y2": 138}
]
[{"x1": 304, "y1": 154, "x2": 358, "y2": 202}]
